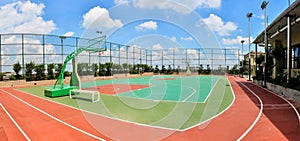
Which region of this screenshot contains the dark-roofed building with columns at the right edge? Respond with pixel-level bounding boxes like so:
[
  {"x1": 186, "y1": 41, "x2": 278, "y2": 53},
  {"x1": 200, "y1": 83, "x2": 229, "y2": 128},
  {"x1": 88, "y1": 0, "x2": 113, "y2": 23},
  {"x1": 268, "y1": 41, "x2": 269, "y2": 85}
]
[{"x1": 253, "y1": 0, "x2": 300, "y2": 81}]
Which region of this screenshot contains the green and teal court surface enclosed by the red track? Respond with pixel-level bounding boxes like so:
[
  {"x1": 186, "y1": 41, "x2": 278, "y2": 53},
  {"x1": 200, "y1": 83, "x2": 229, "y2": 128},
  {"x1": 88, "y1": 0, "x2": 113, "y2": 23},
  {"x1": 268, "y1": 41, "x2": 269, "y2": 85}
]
[{"x1": 19, "y1": 76, "x2": 234, "y2": 131}]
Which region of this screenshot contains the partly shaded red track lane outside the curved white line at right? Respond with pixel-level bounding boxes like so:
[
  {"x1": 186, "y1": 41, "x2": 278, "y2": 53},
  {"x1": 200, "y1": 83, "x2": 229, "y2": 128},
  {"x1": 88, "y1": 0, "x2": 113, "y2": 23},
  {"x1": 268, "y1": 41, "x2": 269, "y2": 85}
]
[{"x1": 236, "y1": 77, "x2": 300, "y2": 141}]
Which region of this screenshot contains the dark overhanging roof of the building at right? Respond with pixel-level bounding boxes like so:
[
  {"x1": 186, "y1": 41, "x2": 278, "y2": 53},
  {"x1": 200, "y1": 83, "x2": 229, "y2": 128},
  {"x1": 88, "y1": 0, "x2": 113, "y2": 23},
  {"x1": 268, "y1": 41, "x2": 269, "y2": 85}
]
[{"x1": 253, "y1": 0, "x2": 300, "y2": 46}]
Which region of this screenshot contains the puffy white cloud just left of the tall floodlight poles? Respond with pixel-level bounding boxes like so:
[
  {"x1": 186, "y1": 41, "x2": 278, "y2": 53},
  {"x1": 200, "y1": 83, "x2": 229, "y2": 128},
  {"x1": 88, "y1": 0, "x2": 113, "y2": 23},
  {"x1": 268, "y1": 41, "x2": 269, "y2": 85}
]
[{"x1": 198, "y1": 14, "x2": 237, "y2": 36}]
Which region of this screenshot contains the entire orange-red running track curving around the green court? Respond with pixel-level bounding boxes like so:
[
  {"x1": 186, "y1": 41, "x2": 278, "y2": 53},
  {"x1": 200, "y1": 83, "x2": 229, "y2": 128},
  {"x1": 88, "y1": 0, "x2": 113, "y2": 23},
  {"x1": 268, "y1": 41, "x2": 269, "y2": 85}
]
[{"x1": 0, "y1": 77, "x2": 300, "y2": 141}]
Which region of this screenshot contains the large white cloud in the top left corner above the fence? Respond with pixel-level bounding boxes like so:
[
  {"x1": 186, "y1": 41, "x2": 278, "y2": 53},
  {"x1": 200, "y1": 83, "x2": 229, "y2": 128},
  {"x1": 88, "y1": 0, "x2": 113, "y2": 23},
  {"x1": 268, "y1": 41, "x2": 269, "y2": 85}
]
[{"x1": 0, "y1": 1, "x2": 56, "y2": 34}]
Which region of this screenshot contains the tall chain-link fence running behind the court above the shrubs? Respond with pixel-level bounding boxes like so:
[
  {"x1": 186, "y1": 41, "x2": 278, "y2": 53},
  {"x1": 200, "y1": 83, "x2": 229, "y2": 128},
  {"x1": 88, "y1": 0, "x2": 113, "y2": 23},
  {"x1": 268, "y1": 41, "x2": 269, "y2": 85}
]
[{"x1": 0, "y1": 34, "x2": 239, "y2": 77}]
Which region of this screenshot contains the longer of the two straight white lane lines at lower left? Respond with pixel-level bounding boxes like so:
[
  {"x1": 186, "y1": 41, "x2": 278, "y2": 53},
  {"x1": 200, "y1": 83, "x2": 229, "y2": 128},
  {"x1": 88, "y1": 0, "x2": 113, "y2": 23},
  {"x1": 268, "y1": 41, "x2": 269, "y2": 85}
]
[{"x1": 1, "y1": 90, "x2": 105, "y2": 141}]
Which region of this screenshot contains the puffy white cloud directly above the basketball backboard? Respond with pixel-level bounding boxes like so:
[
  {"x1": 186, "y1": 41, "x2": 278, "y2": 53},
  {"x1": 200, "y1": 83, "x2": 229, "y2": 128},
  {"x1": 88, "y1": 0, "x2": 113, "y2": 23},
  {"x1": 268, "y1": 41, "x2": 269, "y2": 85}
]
[{"x1": 82, "y1": 6, "x2": 123, "y2": 29}]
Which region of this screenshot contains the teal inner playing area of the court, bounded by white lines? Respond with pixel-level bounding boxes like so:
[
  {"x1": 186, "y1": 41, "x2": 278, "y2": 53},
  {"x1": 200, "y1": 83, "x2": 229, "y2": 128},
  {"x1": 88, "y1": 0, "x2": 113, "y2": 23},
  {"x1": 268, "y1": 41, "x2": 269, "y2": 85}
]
[{"x1": 115, "y1": 76, "x2": 221, "y2": 102}]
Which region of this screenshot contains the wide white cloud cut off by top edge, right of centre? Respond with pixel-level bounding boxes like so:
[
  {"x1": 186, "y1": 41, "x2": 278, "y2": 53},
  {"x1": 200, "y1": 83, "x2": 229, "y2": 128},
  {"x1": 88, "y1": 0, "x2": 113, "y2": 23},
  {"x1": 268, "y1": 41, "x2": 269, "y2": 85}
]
[{"x1": 133, "y1": 0, "x2": 221, "y2": 14}]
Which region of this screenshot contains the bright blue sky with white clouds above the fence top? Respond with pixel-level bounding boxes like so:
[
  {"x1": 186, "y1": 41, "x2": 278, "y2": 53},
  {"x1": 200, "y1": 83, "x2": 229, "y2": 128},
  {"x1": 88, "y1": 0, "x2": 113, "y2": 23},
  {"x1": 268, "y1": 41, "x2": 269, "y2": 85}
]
[{"x1": 0, "y1": 0, "x2": 294, "y2": 51}]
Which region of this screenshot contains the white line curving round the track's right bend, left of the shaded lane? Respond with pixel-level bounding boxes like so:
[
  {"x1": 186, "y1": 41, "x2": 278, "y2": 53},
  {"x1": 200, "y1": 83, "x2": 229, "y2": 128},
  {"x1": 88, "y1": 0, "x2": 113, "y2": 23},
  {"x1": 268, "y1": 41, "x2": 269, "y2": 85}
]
[{"x1": 234, "y1": 78, "x2": 263, "y2": 141}]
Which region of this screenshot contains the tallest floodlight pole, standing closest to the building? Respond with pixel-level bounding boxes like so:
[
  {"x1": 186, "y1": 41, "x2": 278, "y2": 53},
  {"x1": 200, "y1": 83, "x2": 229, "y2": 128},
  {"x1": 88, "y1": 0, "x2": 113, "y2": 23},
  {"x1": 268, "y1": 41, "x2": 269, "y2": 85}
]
[{"x1": 261, "y1": 1, "x2": 269, "y2": 87}]
